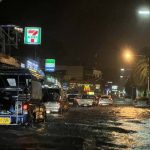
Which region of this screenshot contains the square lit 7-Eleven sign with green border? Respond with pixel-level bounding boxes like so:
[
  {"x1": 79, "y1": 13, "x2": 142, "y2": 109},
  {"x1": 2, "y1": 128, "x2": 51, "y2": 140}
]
[{"x1": 24, "y1": 27, "x2": 41, "y2": 44}]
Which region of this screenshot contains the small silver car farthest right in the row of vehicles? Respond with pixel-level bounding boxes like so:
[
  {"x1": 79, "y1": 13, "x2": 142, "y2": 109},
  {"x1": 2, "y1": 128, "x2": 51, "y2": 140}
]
[{"x1": 98, "y1": 95, "x2": 113, "y2": 105}]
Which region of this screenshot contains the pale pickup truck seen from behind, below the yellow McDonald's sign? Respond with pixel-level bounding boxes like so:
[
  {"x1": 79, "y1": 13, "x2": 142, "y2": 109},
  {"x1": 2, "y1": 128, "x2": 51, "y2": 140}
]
[{"x1": 74, "y1": 94, "x2": 95, "y2": 106}]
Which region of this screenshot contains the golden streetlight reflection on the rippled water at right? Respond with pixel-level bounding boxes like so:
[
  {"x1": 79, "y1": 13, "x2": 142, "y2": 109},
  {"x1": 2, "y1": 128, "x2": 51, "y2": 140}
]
[{"x1": 112, "y1": 107, "x2": 150, "y2": 149}]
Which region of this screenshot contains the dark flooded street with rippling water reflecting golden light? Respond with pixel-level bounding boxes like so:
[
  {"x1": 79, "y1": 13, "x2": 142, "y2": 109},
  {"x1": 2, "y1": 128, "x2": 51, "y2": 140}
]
[{"x1": 0, "y1": 106, "x2": 150, "y2": 150}]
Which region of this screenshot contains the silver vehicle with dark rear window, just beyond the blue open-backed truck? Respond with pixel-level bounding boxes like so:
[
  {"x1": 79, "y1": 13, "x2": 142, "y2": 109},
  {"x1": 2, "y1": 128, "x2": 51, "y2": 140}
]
[{"x1": 42, "y1": 88, "x2": 69, "y2": 114}]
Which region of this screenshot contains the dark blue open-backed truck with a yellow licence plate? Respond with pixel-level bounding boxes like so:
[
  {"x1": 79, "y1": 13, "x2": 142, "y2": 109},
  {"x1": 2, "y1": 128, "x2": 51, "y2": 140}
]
[{"x1": 0, "y1": 69, "x2": 46, "y2": 125}]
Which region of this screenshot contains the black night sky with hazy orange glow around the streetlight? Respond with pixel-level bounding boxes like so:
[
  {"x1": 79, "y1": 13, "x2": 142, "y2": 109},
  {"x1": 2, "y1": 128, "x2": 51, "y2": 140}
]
[{"x1": 0, "y1": 0, "x2": 150, "y2": 80}]
